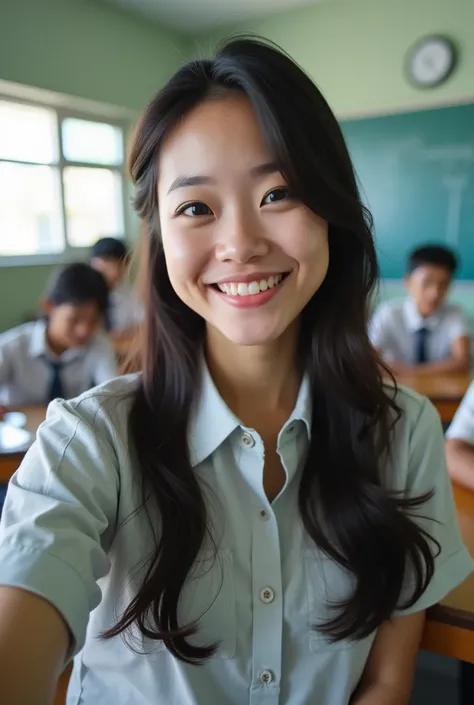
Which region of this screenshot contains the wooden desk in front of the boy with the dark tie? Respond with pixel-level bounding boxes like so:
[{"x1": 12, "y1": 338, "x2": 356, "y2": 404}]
[{"x1": 397, "y1": 373, "x2": 472, "y2": 424}]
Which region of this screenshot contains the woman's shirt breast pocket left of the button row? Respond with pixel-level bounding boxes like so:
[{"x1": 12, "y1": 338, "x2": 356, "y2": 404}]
[{"x1": 178, "y1": 549, "x2": 237, "y2": 659}]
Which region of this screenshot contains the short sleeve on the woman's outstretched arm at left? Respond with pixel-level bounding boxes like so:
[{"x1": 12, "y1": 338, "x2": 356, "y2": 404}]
[{"x1": 0, "y1": 400, "x2": 119, "y2": 652}]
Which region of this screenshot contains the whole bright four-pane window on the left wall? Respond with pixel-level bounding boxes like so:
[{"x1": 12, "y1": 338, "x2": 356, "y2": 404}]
[{"x1": 0, "y1": 97, "x2": 125, "y2": 264}]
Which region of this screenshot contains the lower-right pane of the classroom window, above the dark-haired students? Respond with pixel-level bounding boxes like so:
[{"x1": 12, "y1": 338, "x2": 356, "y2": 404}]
[{"x1": 64, "y1": 167, "x2": 123, "y2": 247}]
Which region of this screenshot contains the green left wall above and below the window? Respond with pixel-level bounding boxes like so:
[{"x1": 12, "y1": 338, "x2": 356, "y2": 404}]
[{"x1": 0, "y1": 0, "x2": 192, "y2": 331}]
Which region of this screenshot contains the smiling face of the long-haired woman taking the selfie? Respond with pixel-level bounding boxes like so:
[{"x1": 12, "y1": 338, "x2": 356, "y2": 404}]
[{"x1": 158, "y1": 94, "x2": 329, "y2": 345}]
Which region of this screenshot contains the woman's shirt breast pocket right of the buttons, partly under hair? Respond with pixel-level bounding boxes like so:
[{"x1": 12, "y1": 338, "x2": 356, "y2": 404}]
[{"x1": 305, "y1": 550, "x2": 375, "y2": 658}]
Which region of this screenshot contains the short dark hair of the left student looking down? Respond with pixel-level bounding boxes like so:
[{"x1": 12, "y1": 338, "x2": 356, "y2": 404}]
[{"x1": 46, "y1": 262, "x2": 109, "y2": 313}]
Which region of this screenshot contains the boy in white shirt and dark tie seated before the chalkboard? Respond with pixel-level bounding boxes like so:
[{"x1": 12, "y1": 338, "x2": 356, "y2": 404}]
[{"x1": 370, "y1": 245, "x2": 470, "y2": 374}]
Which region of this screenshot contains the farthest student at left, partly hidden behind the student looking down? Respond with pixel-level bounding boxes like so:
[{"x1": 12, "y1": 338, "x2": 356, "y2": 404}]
[{"x1": 90, "y1": 237, "x2": 140, "y2": 338}]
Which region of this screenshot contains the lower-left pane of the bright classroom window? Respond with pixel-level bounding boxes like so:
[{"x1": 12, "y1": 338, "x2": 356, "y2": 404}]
[{"x1": 0, "y1": 162, "x2": 64, "y2": 256}]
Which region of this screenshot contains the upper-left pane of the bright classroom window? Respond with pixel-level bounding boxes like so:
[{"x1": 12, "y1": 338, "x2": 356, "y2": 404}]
[{"x1": 0, "y1": 100, "x2": 58, "y2": 164}]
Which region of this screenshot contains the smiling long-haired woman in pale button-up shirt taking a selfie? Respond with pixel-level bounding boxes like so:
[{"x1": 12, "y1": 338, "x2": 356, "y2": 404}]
[{"x1": 0, "y1": 39, "x2": 473, "y2": 705}]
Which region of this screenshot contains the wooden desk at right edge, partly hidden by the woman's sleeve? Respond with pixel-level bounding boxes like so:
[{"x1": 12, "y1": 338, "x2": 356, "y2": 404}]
[{"x1": 422, "y1": 485, "x2": 474, "y2": 663}]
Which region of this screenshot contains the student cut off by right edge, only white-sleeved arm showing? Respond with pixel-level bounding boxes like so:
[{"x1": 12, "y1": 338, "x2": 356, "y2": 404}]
[{"x1": 446, "y1": 382, "x2": 474, "y2": 491}]
